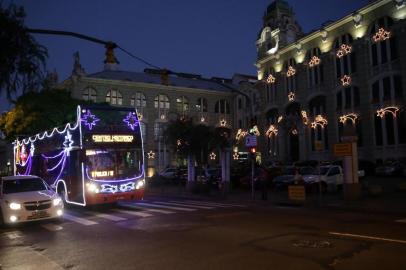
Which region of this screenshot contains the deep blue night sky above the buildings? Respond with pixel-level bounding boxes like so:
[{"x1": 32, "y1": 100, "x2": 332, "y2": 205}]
[{"x1": 0, "y1": 0, "x2": 368, "y2": 110}]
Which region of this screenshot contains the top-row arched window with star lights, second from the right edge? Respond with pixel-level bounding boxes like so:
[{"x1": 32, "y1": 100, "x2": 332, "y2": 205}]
[{"x1": 334, "y1": 34, "x2": 356, "y2": 79}]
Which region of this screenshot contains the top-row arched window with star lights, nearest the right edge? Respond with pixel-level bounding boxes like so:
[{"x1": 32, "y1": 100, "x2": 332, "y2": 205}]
[{"x1": 369, "y1": 17, "x2": 398, "y2": 66}]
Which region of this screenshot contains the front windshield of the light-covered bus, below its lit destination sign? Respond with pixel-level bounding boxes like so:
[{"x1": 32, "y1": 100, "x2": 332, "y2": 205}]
[{"x1": 86, "y1": 149, "x2": 142, "y2": 180}]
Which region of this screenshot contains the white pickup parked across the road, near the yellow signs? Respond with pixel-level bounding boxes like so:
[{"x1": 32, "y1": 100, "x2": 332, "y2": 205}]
[{"x1": 303, "y1": 165, "x2": 344, "y2": 192}]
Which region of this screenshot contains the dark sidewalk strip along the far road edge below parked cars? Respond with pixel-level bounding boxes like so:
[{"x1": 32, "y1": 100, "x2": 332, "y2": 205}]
[{"x1": 146, "y1": 186, "x2": 406, "y2": 215}]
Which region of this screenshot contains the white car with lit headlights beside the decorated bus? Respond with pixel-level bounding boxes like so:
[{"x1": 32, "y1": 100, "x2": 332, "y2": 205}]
[{"x1": 0, "y1": 176, "x2": 63, "y2": 224}]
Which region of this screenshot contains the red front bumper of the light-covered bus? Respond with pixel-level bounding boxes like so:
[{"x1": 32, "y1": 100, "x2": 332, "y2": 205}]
[{"x1": 86, "y1": 188, "x2": 144, "y2": 205}]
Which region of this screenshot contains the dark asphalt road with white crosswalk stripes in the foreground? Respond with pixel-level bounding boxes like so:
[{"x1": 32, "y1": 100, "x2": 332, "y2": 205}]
[{"x1": 0, "y1": 197, "x2": 406, "y2": 270}]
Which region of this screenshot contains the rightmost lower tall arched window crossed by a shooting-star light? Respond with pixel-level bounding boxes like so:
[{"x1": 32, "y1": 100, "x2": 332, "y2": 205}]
[{"x1": 371, "y1": 75, "x2": 406, "y2": 145}]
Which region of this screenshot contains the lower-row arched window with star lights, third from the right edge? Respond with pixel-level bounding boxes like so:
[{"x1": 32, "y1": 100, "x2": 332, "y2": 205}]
[{"x1": 309, "y1": 96, "x2": 328, "y2": 151}]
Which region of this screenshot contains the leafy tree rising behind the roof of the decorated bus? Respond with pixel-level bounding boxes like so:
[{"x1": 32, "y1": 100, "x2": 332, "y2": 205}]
[{"x1": 0, "y1": 89, "x2": 89, "y2": 141}]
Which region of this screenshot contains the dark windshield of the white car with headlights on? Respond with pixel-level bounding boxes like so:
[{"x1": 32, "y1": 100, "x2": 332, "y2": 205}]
[{"x1": 3, "y1": 178, "x2": 48, "y2": 194}]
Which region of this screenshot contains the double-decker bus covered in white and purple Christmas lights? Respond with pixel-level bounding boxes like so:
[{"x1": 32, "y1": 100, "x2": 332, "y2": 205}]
[{"x1": 14, "y1": 105, "x2": 145, "y2": 206}]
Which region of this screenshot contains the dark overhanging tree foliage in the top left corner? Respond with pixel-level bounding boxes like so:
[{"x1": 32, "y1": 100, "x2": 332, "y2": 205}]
[{"x1": 0, "y1": 2, "x2": 48, "y2": 100}]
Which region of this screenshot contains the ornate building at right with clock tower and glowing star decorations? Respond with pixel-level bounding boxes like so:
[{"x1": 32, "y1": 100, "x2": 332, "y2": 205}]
[{"x1": 256, "y1": 0, "x2": 406, "y2": 161}]
